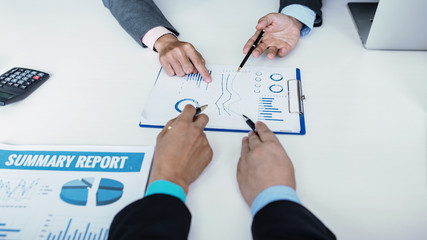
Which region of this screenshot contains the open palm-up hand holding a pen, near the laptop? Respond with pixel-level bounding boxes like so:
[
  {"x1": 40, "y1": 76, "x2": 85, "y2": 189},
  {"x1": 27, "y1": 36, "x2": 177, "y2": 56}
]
[{"x1": 243, "y1": 13, "x2": 303, "y2": 59}]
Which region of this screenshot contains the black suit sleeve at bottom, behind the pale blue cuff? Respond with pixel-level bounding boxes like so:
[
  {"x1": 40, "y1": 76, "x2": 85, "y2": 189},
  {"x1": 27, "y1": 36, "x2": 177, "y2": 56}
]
[{"x1": 252, "y1": 200, "x2": 336, "y2": 240}]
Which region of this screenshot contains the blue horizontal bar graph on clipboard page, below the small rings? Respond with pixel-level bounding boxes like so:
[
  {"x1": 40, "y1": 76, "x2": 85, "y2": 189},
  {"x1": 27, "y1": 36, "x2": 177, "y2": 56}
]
[{"x1": 258, "y1": 97, "x2": 283, "y2": 121}]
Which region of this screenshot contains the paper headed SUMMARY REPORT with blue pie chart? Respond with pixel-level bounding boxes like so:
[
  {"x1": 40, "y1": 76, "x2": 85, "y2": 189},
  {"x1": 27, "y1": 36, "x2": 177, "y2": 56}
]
[{"x1": 0, "y1": 144, "x2": 154, "y2": 239}]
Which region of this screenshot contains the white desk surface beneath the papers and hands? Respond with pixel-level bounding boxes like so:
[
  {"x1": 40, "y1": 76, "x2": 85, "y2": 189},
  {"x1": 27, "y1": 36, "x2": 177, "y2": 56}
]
[{"x1": 0, "y1": 0, "x2": 427, "y2": 240}]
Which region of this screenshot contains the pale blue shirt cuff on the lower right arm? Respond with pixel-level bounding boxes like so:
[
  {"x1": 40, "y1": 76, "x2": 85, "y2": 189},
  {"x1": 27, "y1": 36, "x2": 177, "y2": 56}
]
[{"x1": 251, "y1": 185, "x2": 301, "y2": 216}]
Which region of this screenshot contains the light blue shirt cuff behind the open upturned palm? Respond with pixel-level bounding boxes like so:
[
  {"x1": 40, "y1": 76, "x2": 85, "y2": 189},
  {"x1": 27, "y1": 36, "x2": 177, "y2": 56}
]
[{"x1": 281, "y1": 4, "x2": 316, "y2": 37}]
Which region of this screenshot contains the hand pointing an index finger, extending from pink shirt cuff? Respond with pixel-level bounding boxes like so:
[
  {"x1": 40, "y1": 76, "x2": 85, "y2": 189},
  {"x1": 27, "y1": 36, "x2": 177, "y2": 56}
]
[{"x1": 154, "y1": 34, "x2": 212, "y2": 83}]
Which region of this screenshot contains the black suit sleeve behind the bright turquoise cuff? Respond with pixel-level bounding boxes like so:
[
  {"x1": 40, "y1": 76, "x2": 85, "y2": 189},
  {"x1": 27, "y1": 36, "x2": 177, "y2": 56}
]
[{"x1": 108, "y1": 194, "x2": 191, "y2": 240}]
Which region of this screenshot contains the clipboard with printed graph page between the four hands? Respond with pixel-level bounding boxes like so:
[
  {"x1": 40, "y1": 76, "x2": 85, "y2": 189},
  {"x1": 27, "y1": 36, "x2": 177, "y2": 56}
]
[{"x1": 140, "y1": 65, "x2": 301, "y2": 133}]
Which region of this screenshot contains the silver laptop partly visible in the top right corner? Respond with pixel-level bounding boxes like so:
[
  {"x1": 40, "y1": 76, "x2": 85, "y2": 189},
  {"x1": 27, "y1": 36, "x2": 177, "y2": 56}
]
[{"x1": 348, "y1": 0, "x2": 427, "y2": 50}]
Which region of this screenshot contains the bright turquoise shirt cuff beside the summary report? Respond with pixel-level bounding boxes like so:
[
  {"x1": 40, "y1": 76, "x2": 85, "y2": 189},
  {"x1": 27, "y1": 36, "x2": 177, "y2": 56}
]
[{"x1": 144, "y1": 180, "x2": 186, "y2": 203}]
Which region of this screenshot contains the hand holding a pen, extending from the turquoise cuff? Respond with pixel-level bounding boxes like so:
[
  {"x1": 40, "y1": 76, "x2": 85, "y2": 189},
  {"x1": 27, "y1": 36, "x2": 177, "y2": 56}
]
[{"x1": 149, "y1": 105, "x2": 213, "y2": 193}]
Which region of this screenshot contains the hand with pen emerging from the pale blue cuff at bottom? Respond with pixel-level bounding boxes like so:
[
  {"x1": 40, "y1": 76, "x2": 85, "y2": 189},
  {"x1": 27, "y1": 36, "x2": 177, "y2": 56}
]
[{"x1": 237, "y1": 122, "x2": 296, "y2": 206}]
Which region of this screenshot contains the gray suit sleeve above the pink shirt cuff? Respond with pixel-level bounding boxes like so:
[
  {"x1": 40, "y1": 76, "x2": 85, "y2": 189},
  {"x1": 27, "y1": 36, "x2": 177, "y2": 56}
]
[{"x1": 102, "y1": 0, "x2": 179, "y2": 47}]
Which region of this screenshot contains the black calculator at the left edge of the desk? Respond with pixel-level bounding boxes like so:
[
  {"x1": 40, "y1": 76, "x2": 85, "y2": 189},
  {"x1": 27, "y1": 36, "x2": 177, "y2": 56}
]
[{"x1": 0, "y1": 67, "x2": 49, "y2": 106}]
